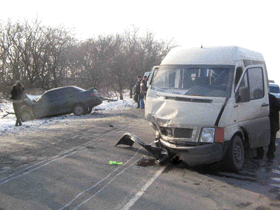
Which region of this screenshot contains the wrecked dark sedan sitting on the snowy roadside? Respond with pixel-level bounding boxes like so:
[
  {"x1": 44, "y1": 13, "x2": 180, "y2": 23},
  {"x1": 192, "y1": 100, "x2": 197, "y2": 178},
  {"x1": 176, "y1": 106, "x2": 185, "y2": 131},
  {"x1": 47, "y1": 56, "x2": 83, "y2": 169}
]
[{"x1": 21, "y1": 86, "x2": 102, "y2": 121}]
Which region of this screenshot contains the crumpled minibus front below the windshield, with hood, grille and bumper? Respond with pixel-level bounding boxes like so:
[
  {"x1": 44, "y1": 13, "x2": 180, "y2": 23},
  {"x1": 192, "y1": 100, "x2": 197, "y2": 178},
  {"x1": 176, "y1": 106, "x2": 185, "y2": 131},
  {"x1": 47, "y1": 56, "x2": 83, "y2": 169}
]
[{"x1": 145, "y1": 98, "x2": 225, "y2": 166}]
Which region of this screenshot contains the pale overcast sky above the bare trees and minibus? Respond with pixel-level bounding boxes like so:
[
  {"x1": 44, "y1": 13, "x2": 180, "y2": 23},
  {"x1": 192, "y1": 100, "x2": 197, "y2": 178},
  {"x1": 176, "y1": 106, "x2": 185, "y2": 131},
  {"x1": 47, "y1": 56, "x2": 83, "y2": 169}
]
[{"x1": 0, "y1": 0, "x2": 280, "y2": 84}]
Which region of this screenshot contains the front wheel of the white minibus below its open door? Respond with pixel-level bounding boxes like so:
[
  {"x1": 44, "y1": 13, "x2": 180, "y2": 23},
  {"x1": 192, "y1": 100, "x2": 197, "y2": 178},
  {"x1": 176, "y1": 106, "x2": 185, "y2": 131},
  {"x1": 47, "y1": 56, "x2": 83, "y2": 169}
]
[{"x1": 223, "y1": 135, "x2": 244, "y2": 171}]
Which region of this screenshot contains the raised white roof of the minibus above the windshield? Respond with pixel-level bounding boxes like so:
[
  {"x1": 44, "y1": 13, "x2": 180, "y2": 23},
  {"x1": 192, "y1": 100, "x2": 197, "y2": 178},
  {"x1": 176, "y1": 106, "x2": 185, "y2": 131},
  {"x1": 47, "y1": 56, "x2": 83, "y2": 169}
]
[{"x1": 161, "y1": 46, "x2": 264, "y2": 65}]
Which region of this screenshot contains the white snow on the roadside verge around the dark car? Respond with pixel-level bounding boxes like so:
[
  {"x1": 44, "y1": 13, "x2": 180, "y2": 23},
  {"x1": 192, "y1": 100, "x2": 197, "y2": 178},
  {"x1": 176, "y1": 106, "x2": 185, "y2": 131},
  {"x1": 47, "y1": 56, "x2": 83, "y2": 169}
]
[{"x1": 0, "y1": 91, "x2": 137, "y2": 136}]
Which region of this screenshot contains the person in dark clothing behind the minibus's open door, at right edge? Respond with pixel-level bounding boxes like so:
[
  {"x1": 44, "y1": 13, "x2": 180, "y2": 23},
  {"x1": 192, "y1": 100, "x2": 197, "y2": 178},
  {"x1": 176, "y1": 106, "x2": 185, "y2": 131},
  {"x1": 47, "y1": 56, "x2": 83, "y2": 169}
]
[{"x1": 255, "y1": 93, "x2": 280, "y2": 161}]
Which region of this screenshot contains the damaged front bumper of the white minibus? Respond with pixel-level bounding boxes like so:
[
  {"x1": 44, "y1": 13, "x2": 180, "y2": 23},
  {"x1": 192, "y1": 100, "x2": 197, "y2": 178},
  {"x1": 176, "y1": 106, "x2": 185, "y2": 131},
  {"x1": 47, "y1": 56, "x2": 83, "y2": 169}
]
[{"x1": 158, "y1": 139, "x2": 227, "y2": 166}]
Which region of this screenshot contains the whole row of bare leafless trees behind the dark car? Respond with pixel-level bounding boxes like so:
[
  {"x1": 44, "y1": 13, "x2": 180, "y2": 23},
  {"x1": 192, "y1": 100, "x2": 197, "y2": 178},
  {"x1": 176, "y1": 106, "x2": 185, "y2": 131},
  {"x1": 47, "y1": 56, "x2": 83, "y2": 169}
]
[{"x1": 0, "y1": 20, "x2": 177, "y2": 98}]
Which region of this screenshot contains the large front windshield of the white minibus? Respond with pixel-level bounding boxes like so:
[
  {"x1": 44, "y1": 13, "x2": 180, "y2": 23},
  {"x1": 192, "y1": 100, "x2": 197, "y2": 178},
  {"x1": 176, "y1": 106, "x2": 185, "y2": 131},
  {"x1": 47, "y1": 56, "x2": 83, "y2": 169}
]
[{"x1": 151, "y1": 65, "x2": 234, "y2": 97}]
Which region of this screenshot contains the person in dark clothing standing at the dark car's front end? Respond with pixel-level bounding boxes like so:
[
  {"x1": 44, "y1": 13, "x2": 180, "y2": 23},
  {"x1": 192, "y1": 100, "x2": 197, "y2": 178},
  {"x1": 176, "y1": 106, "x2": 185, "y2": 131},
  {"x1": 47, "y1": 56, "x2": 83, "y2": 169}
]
[{"x1": 11, "y1": 81, "x2": 24, "y2": 126}]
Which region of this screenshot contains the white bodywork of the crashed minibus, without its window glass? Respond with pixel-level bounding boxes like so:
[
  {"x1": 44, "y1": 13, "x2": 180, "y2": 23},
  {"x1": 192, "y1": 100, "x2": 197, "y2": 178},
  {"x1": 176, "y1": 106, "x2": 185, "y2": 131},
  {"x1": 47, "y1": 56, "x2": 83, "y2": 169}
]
[{"x1": 145, "y1": 46, "x2": 270, "y2": 165}]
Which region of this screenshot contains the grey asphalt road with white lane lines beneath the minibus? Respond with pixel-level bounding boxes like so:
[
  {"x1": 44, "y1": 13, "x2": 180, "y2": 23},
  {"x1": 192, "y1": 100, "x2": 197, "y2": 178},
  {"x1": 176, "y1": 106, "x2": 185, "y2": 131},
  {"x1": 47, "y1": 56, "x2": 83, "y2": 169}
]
[{"x1": 0, "y1": 109, "x2": 280, "y2": 210}]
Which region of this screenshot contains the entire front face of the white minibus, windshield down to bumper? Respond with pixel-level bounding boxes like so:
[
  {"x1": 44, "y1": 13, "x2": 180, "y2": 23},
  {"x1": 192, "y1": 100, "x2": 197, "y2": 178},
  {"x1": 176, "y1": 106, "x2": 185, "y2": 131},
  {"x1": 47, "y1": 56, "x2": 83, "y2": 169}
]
[{"x1": 115, "y1": 64, "x2": 236, "y2": 166}]
